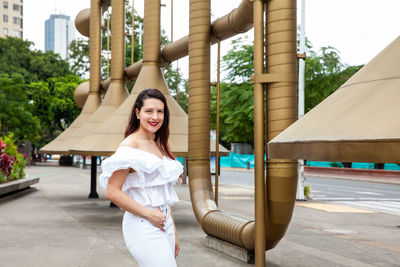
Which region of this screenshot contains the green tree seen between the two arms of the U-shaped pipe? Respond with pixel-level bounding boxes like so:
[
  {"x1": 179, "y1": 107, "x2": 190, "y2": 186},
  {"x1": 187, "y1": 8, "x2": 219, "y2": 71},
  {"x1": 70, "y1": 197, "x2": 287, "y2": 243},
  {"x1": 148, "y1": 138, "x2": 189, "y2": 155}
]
[{"x1": 211, "y1": 38, "x2": 254, "y2": 143}]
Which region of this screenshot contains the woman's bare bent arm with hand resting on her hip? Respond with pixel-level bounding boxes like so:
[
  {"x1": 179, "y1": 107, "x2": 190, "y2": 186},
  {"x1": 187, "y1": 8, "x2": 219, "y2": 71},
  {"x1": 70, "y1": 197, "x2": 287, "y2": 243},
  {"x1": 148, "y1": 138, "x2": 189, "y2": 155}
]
[{"x1": 106, "y1": 169, "x2": 166, "y2": 231}]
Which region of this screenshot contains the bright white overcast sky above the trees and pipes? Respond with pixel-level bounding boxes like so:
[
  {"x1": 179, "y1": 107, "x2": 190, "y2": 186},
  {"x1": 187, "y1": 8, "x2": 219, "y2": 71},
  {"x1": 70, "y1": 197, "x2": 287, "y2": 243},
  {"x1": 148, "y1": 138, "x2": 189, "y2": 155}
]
[{"x1": 24, "y1": 0, "x2": 400, "y2": 81}]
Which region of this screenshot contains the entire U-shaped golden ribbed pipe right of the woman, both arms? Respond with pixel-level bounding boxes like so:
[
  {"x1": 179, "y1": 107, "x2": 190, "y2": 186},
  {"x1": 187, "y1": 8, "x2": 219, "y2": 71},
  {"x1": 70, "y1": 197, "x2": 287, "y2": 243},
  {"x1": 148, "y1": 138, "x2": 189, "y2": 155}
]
[{"x1": 188, "y1": 0, "x2": 297, "y2": 254}]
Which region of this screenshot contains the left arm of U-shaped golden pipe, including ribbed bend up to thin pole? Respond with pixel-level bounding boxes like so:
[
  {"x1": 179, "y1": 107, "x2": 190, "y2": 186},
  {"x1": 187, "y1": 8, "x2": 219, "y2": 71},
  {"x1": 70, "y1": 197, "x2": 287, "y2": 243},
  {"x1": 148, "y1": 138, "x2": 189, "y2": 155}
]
[{"x1": 188, "y1": 0, "x2": 254, "y2": 253}]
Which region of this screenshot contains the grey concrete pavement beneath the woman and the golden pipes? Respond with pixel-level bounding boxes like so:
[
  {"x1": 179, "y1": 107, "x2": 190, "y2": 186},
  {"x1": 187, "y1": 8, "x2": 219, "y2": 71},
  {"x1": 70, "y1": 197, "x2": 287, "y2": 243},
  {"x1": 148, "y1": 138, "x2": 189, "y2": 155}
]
[{"x1": 0, "y1": 166, "x2": 400, "y2": 267}]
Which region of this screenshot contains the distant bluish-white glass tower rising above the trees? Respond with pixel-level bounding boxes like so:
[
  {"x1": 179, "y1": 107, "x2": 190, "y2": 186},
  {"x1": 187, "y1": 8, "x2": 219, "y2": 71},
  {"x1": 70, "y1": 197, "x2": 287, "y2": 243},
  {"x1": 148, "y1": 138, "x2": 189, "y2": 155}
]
[{"x1": 44, "y1": 15, "x2": 75, "y2": 59}]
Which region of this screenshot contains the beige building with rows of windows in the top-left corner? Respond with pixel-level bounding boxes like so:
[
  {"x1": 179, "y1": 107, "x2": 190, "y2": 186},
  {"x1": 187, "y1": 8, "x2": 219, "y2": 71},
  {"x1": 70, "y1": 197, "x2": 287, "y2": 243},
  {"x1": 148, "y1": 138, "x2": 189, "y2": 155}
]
[{"x1": 0, "y1": 0, "x2": 23, "y2": 38}]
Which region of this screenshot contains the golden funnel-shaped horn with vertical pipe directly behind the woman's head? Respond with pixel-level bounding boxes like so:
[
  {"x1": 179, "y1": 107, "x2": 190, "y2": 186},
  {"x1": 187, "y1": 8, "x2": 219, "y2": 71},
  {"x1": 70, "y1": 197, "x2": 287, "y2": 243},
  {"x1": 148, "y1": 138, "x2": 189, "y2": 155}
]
[{"x1": 71, "y1": 0, "x2": 191, "y2": 156}]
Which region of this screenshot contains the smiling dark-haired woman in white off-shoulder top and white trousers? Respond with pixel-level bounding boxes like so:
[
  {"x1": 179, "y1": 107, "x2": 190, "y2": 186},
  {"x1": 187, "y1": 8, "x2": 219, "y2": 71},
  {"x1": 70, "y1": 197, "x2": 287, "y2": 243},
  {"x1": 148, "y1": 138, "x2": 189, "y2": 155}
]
[{"x1": 99, "y1": 89, "x2": 183, "y2": 267}]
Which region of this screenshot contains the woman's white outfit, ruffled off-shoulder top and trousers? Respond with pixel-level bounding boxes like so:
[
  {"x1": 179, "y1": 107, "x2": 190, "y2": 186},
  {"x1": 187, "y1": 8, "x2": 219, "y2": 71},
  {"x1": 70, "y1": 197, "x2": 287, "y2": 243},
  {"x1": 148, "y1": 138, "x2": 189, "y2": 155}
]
[{"x1": 99, "y1": 146, "x2": 183, "y2": 267}]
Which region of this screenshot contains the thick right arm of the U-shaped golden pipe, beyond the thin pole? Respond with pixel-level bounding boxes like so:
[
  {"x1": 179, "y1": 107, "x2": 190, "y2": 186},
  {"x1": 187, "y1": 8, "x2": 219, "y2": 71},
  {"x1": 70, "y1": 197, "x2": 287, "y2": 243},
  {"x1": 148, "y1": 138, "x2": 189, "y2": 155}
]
[{"x1": 265, "y1": 0, "x2": 297, "y2": 249}]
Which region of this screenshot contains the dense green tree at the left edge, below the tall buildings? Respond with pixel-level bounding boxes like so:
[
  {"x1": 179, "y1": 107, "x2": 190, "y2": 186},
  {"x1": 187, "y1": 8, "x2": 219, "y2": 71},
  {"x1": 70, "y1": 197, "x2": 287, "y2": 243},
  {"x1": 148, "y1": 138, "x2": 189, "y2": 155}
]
[{"x1": 0, "y1": 37, "x2": 81, "y2": 145}]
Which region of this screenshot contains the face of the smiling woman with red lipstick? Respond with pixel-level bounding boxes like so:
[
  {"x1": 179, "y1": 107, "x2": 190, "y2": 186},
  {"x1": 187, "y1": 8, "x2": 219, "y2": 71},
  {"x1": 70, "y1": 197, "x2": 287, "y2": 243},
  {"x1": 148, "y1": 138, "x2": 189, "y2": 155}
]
[{"x1": 135, "y1": 98, "x2": 164, "y2": 134}]
